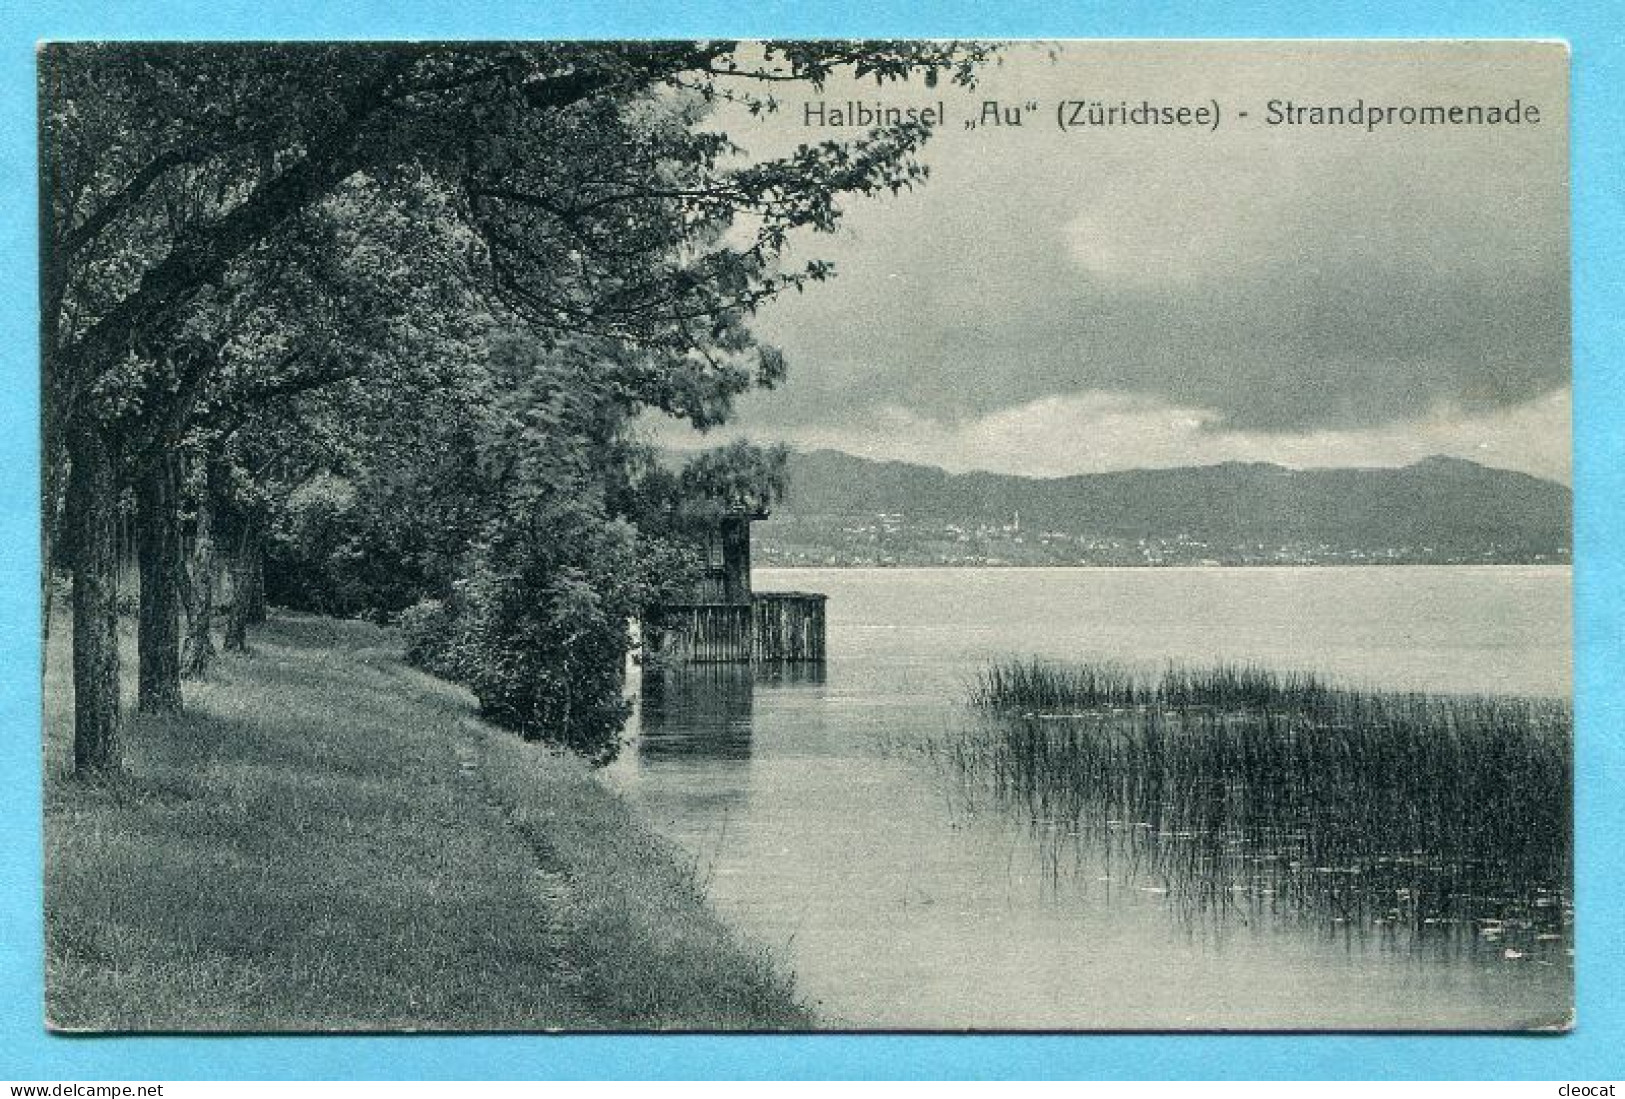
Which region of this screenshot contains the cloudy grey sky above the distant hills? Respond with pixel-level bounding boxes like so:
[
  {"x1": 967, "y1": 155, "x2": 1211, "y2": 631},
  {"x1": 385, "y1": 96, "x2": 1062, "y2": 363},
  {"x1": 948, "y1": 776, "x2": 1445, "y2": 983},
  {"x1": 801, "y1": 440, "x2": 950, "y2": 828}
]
[{"x1": 653, "y1": 42, "x2": 1570, "y2": 481}]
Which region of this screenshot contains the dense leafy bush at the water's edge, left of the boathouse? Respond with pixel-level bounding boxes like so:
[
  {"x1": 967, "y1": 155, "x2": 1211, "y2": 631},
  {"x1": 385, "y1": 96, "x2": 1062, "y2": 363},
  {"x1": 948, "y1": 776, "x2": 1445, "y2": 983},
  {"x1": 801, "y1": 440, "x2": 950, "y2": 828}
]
[{"x1": 406, "y1": 337, "x2": 692, "y2": 759}]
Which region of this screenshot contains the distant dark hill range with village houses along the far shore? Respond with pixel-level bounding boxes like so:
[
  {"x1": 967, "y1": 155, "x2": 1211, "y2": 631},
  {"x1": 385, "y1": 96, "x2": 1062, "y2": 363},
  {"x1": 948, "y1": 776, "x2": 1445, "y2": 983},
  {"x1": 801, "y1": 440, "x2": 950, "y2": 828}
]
[{"x1": 756, "y1": 450, "x2": 1573, "y2": 564}]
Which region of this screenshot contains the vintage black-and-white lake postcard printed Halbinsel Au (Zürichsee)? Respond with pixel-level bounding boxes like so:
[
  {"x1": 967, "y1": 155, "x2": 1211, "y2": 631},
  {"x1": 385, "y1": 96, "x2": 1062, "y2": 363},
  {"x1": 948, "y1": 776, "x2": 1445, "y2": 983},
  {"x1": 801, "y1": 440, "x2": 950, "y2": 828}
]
[{"x1": 37, "y1": 41, "x2": 1575, "y2": 1032}]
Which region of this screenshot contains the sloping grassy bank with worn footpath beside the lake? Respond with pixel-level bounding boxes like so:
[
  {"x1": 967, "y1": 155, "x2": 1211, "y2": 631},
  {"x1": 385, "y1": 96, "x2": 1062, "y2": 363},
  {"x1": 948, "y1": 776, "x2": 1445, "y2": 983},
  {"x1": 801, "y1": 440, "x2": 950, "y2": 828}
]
[{"x1": 46, "y1": 616, "x2": 811, "y2": 1031}]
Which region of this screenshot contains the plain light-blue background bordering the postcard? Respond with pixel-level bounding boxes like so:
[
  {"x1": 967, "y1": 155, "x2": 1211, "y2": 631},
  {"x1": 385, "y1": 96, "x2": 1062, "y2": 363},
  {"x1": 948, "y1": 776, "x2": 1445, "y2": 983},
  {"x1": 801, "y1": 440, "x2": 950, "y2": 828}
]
[{"x1": 0, "y1": 0, "x2": 1625, "y2": 1079}]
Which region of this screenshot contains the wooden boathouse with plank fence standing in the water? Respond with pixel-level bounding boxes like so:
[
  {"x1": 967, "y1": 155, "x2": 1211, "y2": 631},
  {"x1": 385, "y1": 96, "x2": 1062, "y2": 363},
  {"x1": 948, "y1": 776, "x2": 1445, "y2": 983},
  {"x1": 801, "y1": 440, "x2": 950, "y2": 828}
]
[{"x1": 644, "y1": 512, "x2": 826, "y2": 663}]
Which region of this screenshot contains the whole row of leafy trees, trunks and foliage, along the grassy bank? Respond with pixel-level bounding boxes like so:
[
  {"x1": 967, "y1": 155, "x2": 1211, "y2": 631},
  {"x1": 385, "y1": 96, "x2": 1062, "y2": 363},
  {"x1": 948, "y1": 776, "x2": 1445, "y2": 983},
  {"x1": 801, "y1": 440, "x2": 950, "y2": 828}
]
[{"x1": 39, "y1": 42, "x2": 986, "y2": 772}]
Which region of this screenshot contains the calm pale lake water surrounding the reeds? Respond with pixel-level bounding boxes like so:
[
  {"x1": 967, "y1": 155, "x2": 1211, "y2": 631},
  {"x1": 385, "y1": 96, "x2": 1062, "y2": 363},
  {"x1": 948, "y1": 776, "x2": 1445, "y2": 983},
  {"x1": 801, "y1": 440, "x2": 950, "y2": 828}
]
[{"x1": 605, "y1": 567, "x2": 1570, "y2": 1029}]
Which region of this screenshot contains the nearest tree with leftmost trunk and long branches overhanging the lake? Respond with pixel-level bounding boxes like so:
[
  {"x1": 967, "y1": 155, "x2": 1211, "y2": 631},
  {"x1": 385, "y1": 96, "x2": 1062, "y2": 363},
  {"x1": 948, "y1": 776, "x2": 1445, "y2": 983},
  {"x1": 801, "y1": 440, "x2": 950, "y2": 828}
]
[{"x1": 41, "y1": 42, "x2": 985, "y2": 771}]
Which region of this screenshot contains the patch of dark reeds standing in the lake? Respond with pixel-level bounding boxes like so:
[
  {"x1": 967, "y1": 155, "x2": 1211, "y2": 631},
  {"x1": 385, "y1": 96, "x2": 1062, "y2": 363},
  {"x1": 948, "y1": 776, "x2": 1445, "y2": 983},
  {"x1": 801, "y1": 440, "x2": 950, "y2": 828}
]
[{"x1": 942, "y1": 660, "x2": 1573, "y2": 959}]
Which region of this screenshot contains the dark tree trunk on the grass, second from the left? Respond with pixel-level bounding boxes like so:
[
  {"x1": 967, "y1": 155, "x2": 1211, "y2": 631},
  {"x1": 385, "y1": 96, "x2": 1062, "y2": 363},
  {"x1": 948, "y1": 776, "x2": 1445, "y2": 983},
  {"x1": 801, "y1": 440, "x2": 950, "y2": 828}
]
[{"x1": 137, "y1": 454, "x2": 180, "y2": 714}]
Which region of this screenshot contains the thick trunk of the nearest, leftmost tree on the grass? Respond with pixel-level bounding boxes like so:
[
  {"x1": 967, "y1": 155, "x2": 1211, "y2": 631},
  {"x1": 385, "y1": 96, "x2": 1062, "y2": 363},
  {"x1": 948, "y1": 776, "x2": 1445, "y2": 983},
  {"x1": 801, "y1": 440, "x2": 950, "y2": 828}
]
[{"x1": 67, "y1": 428, "x2": 122, "y2": 774}]
